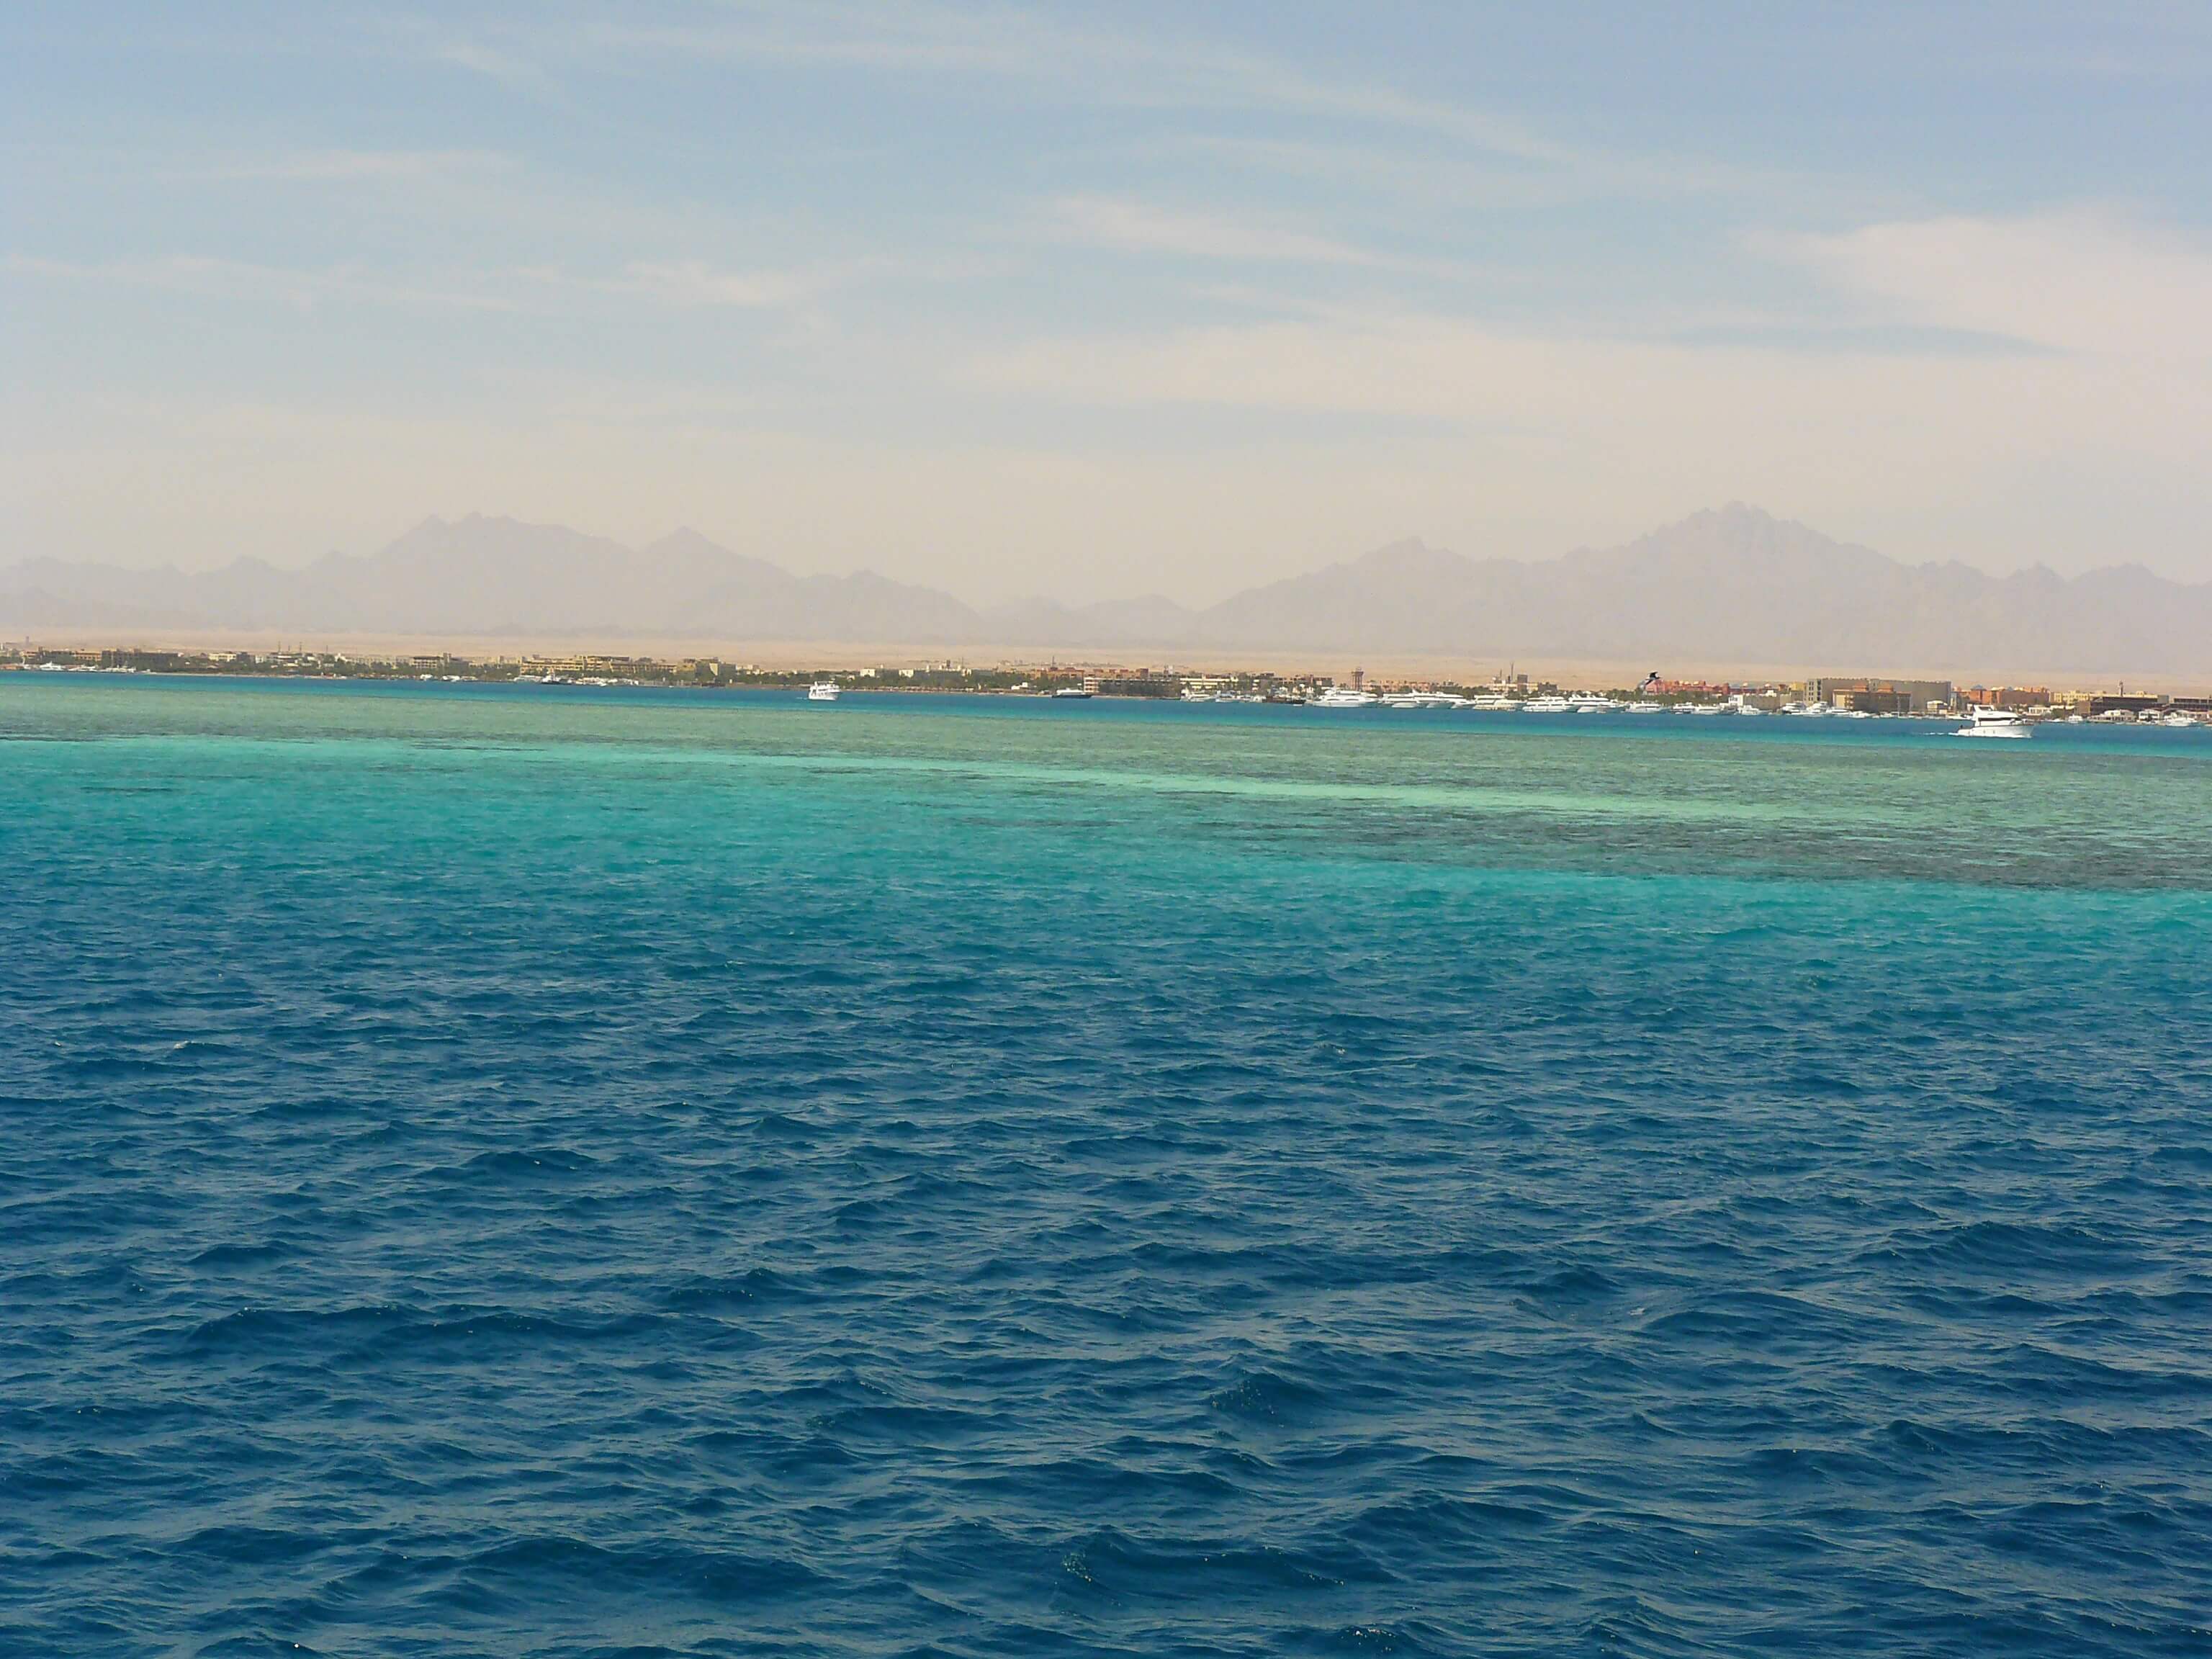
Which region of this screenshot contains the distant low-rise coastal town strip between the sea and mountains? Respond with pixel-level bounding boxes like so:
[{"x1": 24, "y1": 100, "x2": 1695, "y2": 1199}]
[{"x1": 0, "y1": 642, "x2": 2212, "y2": 724}]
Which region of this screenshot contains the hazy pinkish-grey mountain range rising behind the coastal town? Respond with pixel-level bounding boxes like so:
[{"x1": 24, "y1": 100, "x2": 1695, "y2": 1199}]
[{"x1": 0, "y1": 504, "x2": 2212, "y2": 673}]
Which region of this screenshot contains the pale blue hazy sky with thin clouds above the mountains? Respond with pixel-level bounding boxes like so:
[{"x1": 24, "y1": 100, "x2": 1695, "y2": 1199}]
[{"x1": 0, "y1": 0, "x2": 2212, "y2": 600}]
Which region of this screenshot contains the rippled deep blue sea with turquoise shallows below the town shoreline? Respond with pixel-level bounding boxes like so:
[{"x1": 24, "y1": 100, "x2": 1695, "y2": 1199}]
[{"x1": 0, "y1": 675, "x2": 2212, "y2": 1655}]
